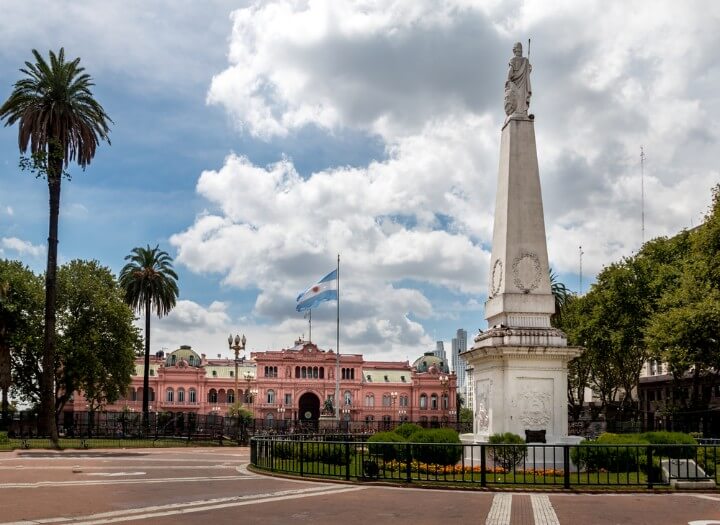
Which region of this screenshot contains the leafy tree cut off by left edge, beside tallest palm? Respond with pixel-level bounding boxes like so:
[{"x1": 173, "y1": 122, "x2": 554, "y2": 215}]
[{"x1": 0, "y1": 259, "x2": 43, "y2": 425}]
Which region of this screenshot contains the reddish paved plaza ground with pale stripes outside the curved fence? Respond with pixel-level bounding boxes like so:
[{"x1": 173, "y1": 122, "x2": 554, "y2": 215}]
[{"x1": 0, "y1": 448, "x2": 720, "y2": 525}]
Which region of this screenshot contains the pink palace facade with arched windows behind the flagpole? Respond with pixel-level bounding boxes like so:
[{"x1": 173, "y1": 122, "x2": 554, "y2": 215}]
[{"x1": 84, "y1": 340, "x2": 457, "y2": 422}]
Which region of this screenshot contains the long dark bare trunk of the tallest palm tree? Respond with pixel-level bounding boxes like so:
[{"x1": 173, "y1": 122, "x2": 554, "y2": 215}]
[{"x1": 39, "y1": 169, "x2": 62, "y2": 446}]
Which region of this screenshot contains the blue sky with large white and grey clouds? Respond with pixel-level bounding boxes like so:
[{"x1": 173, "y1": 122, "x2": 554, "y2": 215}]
[{"x1": 0, "y1": 0, "x2": 720, "y2": 359}]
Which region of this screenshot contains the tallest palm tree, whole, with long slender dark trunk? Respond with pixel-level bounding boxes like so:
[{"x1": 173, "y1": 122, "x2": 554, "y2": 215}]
[{"x1": 0, "y1": 48, "x2": 112, "y2": 444}]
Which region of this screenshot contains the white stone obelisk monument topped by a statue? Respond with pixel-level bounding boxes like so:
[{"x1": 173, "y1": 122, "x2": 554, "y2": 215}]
[{"x1": 462, "y1": 43, "x2": 582, "y2": 443}]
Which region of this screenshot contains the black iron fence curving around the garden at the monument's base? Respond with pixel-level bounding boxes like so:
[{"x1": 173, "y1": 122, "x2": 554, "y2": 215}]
[{"x1": 251, "y1": 435, "x2": 720, "y2": 489}]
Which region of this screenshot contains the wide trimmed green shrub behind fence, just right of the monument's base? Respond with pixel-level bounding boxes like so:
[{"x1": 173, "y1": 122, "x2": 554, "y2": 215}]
[{"x1": 570, "y1": 432, "x2": 650, "y2": 472}]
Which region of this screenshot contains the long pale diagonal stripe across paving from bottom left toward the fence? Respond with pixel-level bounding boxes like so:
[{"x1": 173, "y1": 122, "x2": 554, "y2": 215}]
[{"x1": 0, "y1": 485, "x2": 365, "y2": 525}]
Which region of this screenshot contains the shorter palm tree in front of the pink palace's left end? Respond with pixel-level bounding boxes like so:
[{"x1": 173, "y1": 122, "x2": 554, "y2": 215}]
[{"x1": 120, "y1": 245, "x2": 178, "y2": 427}]
